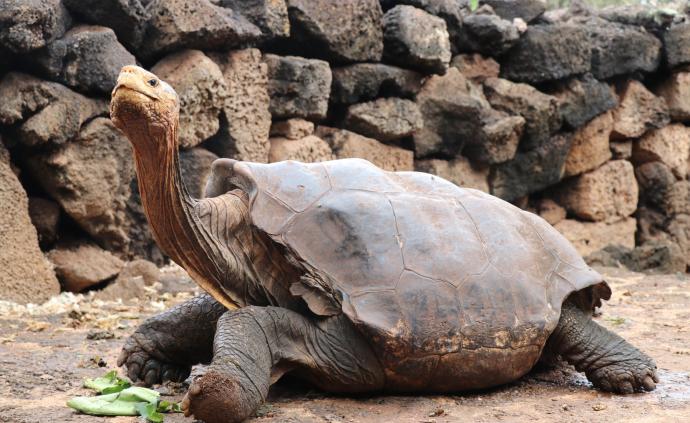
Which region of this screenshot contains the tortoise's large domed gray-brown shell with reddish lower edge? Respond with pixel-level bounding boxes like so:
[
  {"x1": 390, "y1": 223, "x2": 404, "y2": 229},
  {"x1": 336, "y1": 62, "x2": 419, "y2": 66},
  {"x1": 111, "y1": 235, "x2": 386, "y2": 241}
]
[{"x1": 212, "y1": 159, "x2": 603, "y2": 391}]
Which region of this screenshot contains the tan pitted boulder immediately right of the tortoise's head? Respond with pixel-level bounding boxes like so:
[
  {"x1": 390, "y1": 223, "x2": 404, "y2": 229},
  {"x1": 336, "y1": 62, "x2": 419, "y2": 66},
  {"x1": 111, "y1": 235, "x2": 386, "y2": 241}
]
[{"x1": 151, "y1": 50, "x2": 227, "y2": 148}]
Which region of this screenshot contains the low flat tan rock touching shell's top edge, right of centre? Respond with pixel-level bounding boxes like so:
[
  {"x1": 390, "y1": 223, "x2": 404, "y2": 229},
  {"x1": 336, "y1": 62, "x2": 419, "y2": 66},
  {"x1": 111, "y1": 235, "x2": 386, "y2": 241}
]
[{"x1": 415, "y1": 156, "x2": 489, "y2": 192}]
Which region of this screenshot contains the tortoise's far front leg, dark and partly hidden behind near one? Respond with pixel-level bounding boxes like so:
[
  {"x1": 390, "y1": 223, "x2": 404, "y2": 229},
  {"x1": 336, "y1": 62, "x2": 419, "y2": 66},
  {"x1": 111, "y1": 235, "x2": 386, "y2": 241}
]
[{"x1": 117, "y1": 294, "x2": 227, "y2": 385}]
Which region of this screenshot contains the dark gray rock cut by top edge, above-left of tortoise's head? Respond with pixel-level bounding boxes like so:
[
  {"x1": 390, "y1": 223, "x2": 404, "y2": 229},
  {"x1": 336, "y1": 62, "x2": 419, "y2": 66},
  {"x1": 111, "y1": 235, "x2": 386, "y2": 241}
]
[{"x1": 62, "y1": 0, "x2": 153, "y2": 50}]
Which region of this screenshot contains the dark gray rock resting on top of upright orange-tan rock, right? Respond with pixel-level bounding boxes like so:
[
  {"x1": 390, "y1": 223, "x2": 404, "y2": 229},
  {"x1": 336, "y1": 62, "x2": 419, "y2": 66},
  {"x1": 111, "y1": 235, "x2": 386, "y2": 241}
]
[{"x1": 549, "y1": 73, "x2": 618, "y2": 129}]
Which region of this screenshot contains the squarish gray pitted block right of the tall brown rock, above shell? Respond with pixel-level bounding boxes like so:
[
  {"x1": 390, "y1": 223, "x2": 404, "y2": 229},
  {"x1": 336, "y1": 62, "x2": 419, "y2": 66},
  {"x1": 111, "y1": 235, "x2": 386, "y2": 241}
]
[{"x1": 264, "y1": 54, "x2": 332, "y2": 120}]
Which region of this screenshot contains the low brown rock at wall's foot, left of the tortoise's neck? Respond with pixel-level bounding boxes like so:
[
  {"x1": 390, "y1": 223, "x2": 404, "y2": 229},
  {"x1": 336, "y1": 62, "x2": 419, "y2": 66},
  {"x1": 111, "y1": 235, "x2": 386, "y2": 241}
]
[{"x1": 48, "y1": 243, "x2": 124, "y2": 292}]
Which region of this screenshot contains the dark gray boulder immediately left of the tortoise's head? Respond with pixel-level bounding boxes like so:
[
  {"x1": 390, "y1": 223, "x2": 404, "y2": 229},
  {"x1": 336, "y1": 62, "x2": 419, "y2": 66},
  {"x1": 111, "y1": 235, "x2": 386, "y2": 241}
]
[{"x1": 31, "y1": 25, "x2": 136, "y2": 94}]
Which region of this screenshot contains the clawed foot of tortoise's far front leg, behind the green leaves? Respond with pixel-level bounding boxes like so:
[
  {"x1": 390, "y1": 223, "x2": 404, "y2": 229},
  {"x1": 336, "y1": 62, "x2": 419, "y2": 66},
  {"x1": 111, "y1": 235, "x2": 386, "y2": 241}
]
[{"x1": 117, "y1": 334, "x2": 192, "y2": 386}]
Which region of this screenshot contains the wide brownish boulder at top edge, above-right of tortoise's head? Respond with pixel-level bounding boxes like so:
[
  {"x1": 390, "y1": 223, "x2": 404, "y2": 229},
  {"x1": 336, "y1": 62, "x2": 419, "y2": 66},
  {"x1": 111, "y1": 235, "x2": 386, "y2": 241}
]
[{"x1": 137, "y1": 0, "x2": 262, "y2": 59}]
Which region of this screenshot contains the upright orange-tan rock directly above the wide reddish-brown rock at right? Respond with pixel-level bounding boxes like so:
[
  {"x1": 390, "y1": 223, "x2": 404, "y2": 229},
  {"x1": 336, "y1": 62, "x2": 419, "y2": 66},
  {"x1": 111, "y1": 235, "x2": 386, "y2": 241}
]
[{"x1": 565, "y1": 112, "x2": 613, "y2": 176}]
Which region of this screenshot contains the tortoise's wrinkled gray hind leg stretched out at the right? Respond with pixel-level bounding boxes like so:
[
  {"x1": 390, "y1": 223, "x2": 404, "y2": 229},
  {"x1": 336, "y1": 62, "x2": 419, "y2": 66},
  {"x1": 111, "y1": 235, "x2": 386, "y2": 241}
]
[{"x1": 547, "y1": 301, "x2": 659, "y2": 394}]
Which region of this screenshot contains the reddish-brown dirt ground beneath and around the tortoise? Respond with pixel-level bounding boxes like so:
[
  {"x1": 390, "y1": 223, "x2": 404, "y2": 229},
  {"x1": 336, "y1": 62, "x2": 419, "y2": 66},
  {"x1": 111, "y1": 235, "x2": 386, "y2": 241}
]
[{"x1": 0, "y1": 269, "x2": 690, "y2": 423}]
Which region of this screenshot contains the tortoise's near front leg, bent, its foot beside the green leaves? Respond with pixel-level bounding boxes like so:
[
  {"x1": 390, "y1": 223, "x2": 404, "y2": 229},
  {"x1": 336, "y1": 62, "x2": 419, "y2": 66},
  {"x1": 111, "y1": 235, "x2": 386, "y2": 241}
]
[{"x1": 182, "y1": 307, "x2": 384, "y2": 423}]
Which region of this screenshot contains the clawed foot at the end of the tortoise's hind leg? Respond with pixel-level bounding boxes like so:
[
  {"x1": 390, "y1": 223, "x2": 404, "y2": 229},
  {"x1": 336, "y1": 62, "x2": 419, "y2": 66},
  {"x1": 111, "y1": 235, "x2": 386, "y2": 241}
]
[{"x1": 587, "y1": 356, "x2": 659, "y2": 394}]
